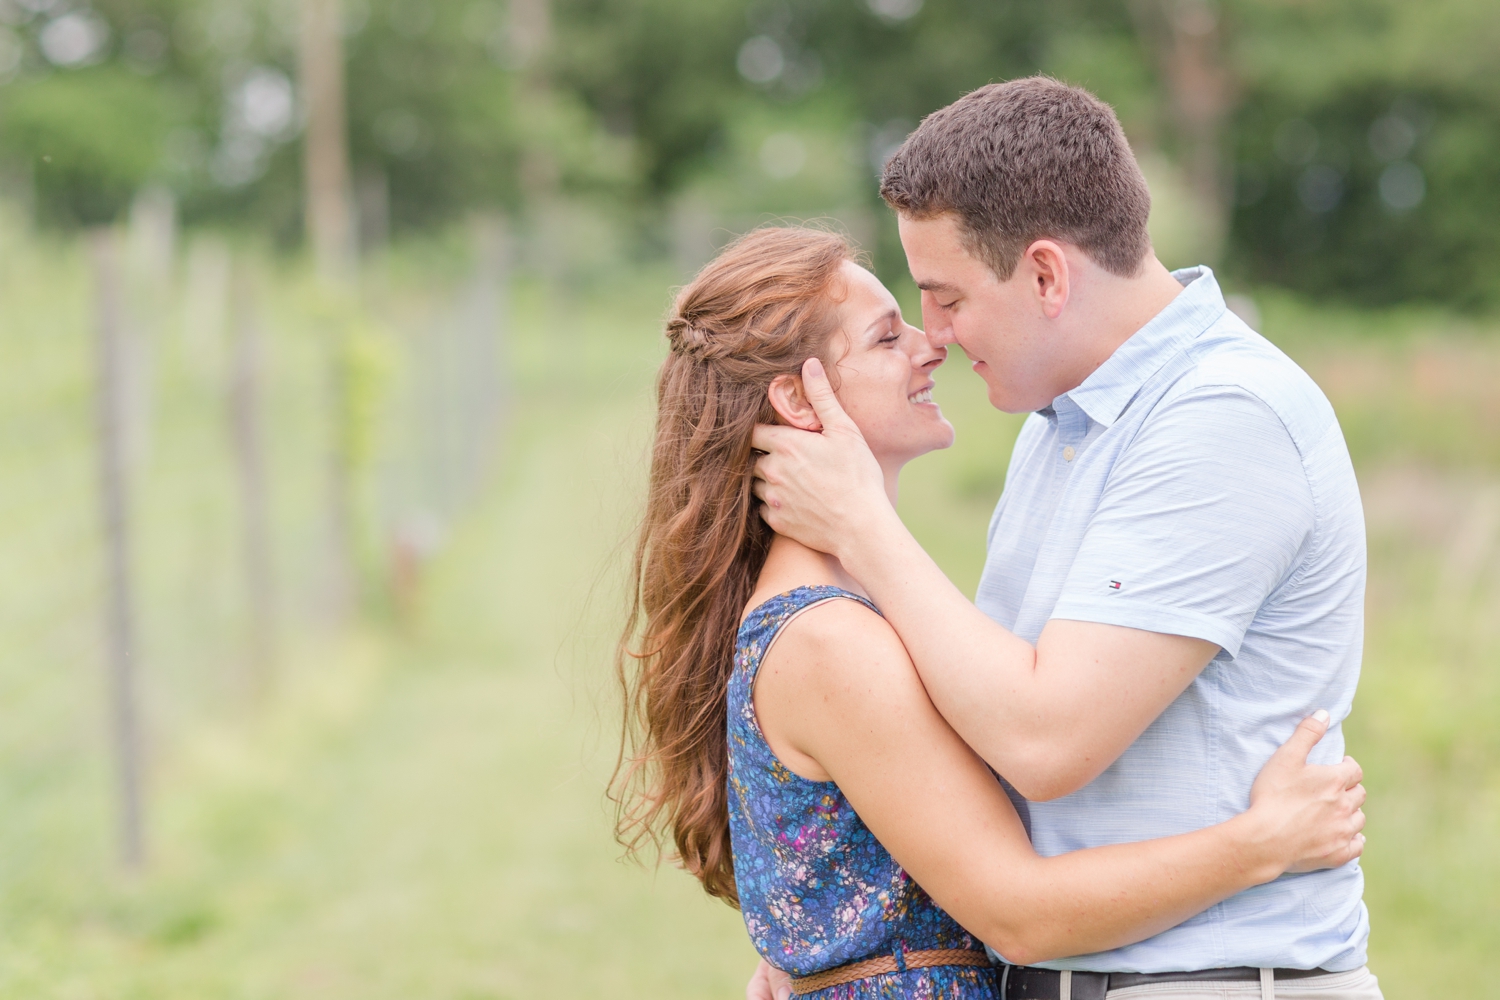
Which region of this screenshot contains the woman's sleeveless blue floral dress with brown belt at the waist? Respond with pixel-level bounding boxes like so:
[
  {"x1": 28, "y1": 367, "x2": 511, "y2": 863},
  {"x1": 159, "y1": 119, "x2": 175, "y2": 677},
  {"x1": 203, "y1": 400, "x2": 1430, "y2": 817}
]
[{"x1": 729, "y1": 586, "x2": 999, "y2": 1000}]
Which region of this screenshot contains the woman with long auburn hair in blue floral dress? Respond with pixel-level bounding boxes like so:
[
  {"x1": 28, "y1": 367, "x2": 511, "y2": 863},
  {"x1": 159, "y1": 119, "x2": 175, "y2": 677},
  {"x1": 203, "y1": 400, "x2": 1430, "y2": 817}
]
[{"x1": 618, "y1": 229, "x2": 1364, "y2": 1000}]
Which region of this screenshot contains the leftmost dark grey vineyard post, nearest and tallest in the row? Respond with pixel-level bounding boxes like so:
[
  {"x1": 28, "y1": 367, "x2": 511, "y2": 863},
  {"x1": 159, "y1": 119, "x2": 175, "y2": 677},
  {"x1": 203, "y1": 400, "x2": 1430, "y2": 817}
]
[{"x1": 90, "y1": 228, "x2": 146, "y2": 870}]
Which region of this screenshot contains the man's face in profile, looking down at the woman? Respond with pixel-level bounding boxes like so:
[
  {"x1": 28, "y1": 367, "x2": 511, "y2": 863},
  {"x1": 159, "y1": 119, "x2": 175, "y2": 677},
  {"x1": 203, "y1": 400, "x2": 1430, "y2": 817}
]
[{"x1": 899, "y1": 213, "x2": 1068, "y2": 412}]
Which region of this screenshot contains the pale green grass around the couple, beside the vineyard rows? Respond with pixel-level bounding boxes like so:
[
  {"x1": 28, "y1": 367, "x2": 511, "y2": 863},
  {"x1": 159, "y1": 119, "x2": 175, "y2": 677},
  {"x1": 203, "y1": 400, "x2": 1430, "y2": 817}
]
[{"x1": 0, "y1": 239, "x2": 1500, "y2": 1000}]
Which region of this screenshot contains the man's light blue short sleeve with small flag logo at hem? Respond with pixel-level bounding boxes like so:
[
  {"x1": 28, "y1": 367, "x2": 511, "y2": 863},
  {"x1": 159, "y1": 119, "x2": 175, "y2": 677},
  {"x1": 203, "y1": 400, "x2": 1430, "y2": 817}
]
[{"x1": 1052, "y1": 385, "x2": 1316, "y2": 657}]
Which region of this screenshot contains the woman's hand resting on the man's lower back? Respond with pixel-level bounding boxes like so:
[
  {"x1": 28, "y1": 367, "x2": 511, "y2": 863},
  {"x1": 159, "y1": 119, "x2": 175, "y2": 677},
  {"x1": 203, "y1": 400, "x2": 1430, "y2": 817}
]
[{"x1": 1245, "y1": 709, "x2": 1365, "y2": 871}]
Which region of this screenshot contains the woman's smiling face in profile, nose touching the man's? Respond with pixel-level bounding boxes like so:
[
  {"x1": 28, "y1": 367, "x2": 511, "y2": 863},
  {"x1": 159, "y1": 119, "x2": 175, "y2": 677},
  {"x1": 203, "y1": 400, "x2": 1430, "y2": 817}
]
[{"x1": 830, "y1": 261, "x2": 953, "y2": 468}]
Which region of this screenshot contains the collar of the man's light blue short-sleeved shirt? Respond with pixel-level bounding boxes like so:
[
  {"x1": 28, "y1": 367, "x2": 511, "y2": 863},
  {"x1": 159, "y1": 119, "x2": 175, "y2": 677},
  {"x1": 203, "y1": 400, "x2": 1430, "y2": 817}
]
[{"x1": 1052, "y1": 265, "x2": 1226, "y2": 427}]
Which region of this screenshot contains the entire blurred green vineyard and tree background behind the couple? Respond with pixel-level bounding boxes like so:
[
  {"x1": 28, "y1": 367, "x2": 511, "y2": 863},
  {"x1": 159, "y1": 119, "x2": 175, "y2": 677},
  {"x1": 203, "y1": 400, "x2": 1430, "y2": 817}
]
[{"x1": 0, "y1": 0, "x2": 1500, "y2": 1000}]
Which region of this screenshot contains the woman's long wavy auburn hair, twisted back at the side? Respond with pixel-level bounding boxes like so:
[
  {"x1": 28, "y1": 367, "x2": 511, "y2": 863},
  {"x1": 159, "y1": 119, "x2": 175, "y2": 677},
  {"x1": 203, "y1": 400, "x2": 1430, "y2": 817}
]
[{"x1": 611, "y1": 228, "x2": 854, "y2": 906}]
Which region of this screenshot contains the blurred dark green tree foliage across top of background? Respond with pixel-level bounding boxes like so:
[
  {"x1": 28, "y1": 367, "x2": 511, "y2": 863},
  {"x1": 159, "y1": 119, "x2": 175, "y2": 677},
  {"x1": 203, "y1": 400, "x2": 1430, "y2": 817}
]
[{"x1": 0, "y1": 0, "x2": 1500, "y2": 289}]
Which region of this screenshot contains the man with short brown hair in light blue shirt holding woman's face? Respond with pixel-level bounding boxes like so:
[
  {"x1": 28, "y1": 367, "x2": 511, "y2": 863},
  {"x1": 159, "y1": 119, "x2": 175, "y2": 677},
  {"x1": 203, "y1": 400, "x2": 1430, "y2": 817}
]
[{"x1": 752, "y1": 78, "x2": 1380, "y2": 1000}]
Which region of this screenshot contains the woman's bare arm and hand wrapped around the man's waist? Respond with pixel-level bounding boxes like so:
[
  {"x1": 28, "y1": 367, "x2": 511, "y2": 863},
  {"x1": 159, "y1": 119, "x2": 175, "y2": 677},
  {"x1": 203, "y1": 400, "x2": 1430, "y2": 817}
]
[{"x1": 755, "y1": 600, "x2": 1364, "y2": 964}]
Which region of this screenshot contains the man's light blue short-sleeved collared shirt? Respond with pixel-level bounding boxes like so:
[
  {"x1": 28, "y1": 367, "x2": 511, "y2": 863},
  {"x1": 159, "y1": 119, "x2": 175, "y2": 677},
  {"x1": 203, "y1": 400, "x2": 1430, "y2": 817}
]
[{"x1": 975, "y1": 267, "x2": 1370, "y2": 973}]
